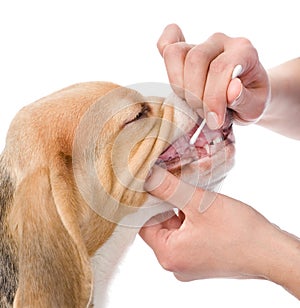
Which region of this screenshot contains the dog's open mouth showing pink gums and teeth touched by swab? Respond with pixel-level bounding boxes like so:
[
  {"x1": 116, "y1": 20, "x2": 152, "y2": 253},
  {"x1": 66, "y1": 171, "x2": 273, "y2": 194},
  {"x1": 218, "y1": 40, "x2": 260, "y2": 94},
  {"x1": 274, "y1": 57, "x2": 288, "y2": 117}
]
[{"x1": 156, "y1": 112, "x2": 235, "y2": 172}]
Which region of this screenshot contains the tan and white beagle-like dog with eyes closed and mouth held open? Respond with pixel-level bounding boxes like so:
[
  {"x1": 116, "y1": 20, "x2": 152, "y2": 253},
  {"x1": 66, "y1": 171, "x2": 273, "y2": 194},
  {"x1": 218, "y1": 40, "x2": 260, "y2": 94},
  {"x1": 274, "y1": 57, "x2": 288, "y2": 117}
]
[{"x1": 0, "y1": 82, "x2": 234, "y2": 308}]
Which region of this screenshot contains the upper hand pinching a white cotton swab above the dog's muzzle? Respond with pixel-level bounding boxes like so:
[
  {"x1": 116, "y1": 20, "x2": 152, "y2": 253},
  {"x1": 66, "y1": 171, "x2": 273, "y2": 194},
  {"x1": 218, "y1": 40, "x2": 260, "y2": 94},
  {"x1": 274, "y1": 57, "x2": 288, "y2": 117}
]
[{"x1": 157, "y1": 24, "x2": 270, "y2": 129}]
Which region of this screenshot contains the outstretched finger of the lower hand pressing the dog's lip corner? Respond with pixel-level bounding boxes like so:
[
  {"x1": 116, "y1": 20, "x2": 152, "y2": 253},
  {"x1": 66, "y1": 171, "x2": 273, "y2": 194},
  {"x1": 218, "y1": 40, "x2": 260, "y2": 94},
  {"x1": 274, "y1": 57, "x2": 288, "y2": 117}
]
[{"x1": 144, "y1": 165, "x2": 216, "y2": 212}]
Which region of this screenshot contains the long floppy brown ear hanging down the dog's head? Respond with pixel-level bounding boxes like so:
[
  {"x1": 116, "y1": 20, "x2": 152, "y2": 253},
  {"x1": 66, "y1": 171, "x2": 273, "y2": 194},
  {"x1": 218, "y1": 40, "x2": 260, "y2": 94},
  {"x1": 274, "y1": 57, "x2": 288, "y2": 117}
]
[{"x1": 10, "y1": 168, "x2": 92, "y2": 307}]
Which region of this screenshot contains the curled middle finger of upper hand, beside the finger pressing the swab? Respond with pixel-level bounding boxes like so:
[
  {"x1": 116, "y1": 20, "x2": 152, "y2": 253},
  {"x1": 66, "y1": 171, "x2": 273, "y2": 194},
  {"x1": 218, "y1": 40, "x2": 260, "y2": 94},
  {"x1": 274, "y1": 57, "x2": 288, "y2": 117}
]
[{"x1": 184, "y1": 41, "x2": 223, "y2": 109}]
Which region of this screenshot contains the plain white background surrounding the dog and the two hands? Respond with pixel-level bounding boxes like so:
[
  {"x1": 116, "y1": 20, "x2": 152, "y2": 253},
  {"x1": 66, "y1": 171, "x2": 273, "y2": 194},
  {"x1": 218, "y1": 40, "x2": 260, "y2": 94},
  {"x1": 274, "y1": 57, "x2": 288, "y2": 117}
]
[{"x1": 0, "y1": 0, "x2": 300, "y2": 308}]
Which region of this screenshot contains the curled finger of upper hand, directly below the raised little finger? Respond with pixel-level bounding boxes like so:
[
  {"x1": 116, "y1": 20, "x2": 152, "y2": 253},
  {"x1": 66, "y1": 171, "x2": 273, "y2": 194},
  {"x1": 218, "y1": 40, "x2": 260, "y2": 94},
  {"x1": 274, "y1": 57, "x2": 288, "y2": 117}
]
[{"x1": 163, "y1": 42, "x2": 192, "y2": 98}]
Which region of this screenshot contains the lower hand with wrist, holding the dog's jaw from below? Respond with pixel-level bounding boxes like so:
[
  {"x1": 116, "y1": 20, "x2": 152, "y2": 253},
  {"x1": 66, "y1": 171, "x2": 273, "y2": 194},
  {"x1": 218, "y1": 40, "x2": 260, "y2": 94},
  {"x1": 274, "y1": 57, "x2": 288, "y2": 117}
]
[{"x1": 140, "y1": 167, "x2": 300, "y2": 297}]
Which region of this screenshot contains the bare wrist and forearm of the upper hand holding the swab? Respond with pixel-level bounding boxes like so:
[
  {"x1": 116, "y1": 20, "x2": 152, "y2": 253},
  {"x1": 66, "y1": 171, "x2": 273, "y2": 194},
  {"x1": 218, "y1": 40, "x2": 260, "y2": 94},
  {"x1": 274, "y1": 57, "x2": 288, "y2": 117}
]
[{"x1": 258, "y1": 58, "x2": 300, "y2": 140}]
